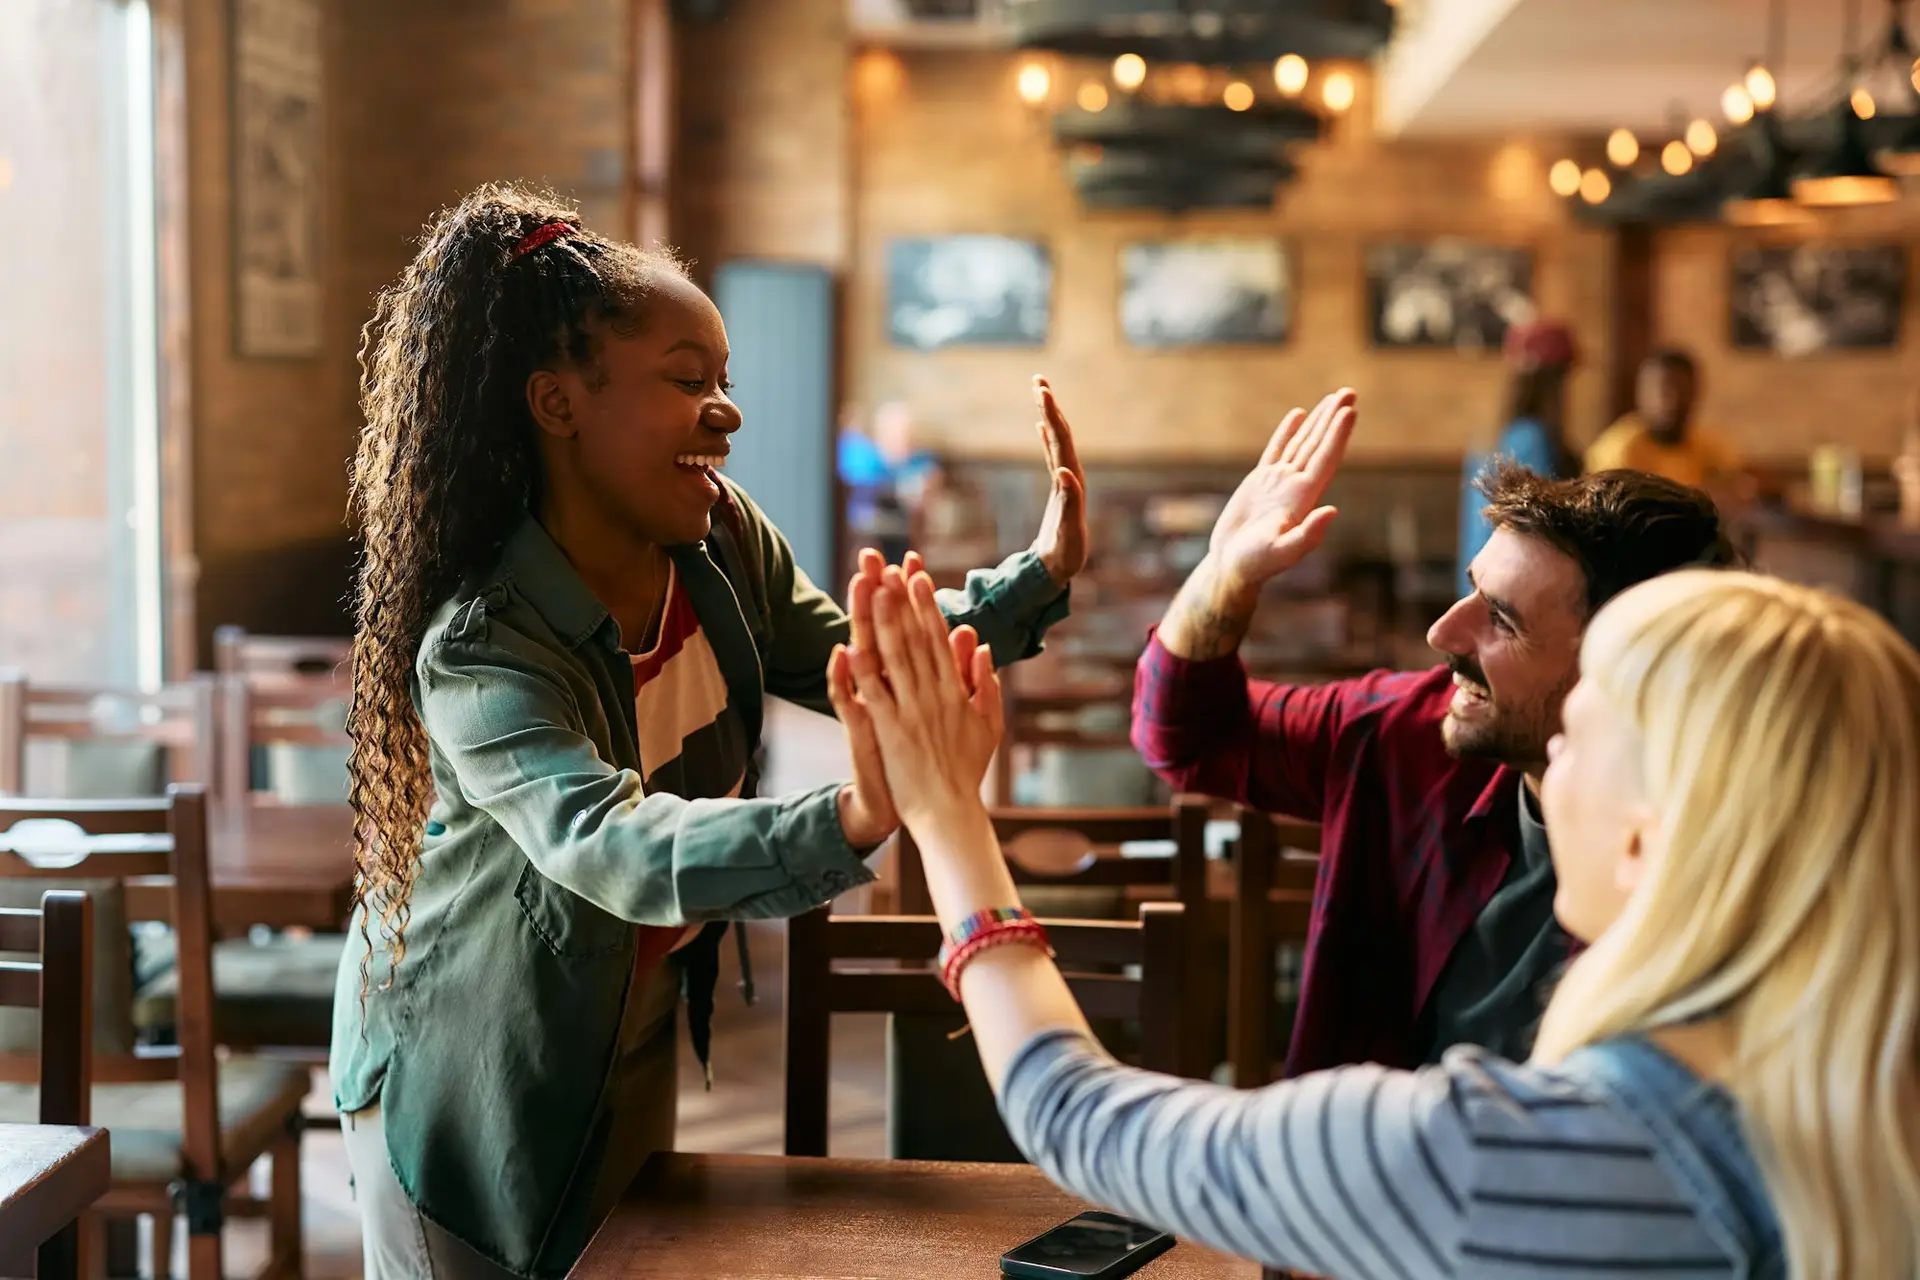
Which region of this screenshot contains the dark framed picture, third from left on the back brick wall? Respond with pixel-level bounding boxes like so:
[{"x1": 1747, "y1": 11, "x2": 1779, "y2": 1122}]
[{"x1": 1367, "y1": 238, "x2": 1534, "y2": 351}]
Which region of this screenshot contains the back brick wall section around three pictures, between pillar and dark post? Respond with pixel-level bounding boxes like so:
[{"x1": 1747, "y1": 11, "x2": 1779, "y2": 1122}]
[{"x1": 849, "y1": 52, "x2": 1609, "y2": 466}]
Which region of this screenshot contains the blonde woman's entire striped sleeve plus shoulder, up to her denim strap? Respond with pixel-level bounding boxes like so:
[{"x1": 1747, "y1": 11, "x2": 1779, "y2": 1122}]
[{"x1": 1000, "y1": 1032, "x2": 1734, "y2": 1280}]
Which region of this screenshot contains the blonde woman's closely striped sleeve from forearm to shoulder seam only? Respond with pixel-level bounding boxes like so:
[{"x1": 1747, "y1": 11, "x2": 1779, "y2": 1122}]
[{"x1": 1000, "y1": 1032, "x2": 1467, "y2": 1276}]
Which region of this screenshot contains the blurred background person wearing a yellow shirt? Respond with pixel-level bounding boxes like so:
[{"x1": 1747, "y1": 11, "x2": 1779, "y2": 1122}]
[{"x1": 1586, "y1": 347, "x2": 1755, "y2": 505}]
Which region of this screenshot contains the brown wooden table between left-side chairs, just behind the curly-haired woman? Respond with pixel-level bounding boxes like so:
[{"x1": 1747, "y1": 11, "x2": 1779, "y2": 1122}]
[{"x1": 127, "y1": 804, "x2": 353, "y2": 933}]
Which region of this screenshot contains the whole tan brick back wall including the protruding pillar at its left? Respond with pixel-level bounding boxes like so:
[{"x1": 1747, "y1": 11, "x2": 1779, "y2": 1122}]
[{"x1": 674, "y1": 10, "x2": 1920, "y2": 462}]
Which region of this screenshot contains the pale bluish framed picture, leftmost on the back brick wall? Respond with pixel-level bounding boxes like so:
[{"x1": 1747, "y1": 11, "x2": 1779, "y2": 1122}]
[{"x1": 887, "y1": 236, "x2": 1054, "y2": 351}]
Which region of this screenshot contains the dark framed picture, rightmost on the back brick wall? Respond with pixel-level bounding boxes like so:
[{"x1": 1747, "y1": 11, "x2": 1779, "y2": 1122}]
[{"x1": 1728, "y1": 244, "x2": 1907, "y2": 355}]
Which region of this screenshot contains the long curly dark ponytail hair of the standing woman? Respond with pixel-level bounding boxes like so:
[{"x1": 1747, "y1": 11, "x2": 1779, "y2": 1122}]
[{"x1": 348, "y1": 184, "x2": 685, "y2": 1000}]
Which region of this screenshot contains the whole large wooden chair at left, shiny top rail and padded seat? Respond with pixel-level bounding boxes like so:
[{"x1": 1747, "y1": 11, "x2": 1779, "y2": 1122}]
[{"x1": 0, "y1": 785, "x2": 311, "y2": 1280}]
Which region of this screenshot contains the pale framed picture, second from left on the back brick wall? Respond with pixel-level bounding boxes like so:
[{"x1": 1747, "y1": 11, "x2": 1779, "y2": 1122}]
[{"x1": 1119, "y1": 240, "x2": 1292, "y2": 347}]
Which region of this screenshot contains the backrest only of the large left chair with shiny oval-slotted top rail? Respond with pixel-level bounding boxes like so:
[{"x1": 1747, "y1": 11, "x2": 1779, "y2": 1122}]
[{"x1": 0, "y1": 783, "x2": 221, "y2": 1159}]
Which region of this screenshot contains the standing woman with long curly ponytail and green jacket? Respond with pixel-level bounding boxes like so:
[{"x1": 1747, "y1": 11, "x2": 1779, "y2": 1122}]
[{"x1": 332, "y1": 186, "x2": 1087, "y2": 1280}]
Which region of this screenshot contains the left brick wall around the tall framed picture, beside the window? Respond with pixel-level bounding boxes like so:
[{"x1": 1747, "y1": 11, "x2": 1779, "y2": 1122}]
[{"x1": 188, "y1": 0, "x2": 630, "y2": 658}]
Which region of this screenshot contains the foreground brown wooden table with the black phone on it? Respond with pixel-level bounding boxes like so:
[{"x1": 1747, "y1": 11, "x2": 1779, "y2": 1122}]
[{"x1": 570, "y1": 1153, "x2": 1260, "y2": 1280}]
